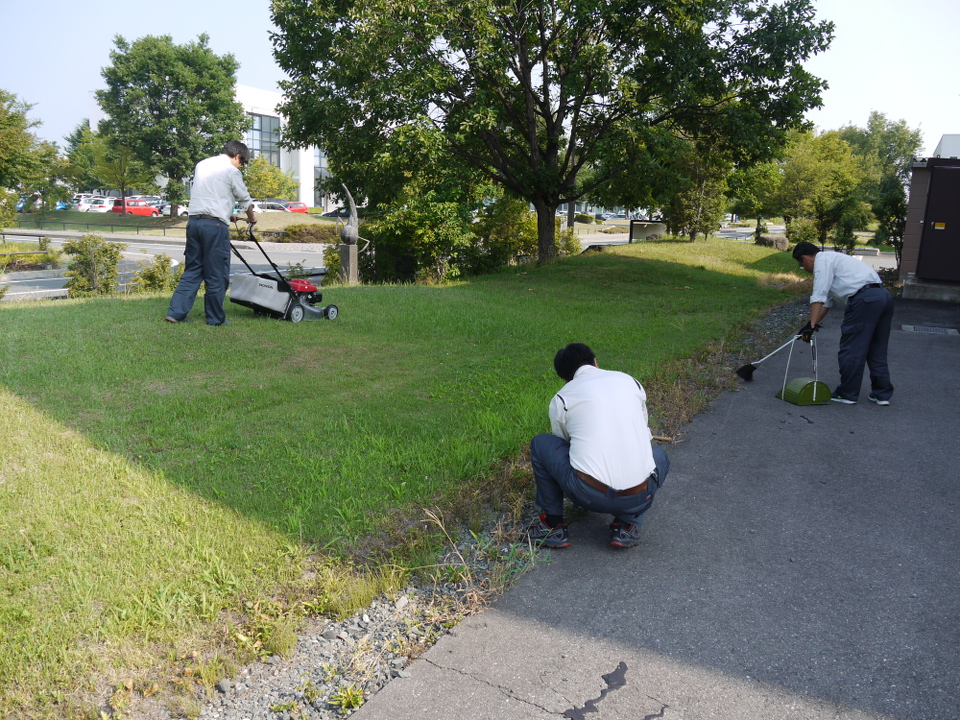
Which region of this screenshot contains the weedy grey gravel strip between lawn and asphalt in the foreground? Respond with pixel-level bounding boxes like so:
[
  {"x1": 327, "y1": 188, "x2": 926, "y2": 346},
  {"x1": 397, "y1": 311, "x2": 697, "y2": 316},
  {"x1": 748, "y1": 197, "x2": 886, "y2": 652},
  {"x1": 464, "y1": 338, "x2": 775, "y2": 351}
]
[{"x1": 129, "y1": 531, "x2": 536, "y2": 720}]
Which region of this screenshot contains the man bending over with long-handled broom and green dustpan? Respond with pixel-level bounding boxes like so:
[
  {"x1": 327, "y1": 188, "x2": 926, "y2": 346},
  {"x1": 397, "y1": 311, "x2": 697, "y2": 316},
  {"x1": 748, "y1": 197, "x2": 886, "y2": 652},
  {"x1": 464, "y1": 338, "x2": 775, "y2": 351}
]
[{"x1": 793, "y1": 242, "x2": 893, "y2": 405}]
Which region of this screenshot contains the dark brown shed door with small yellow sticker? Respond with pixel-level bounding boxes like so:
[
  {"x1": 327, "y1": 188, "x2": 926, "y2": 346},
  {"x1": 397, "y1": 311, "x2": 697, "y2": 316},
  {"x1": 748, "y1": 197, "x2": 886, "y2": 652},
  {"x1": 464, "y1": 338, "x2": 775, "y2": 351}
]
[{"x1": 917, "y1": 165, "x2": 960, "y2": 282}]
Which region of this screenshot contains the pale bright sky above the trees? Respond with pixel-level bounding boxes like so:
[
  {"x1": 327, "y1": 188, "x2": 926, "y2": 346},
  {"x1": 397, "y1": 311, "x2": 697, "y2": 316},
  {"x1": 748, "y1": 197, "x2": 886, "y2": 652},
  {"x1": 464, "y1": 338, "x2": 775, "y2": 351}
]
[{"x1": 0, "y1": 0, "x2": 960, "y2": 154}]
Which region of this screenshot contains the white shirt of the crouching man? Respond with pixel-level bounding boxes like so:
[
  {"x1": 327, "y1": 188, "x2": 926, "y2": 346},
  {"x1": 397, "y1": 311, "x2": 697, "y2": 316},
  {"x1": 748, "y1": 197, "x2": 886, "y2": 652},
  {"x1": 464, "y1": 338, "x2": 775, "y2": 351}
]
[{"x1": 550, "y1": 365, "x2": 656, "y2": 490}]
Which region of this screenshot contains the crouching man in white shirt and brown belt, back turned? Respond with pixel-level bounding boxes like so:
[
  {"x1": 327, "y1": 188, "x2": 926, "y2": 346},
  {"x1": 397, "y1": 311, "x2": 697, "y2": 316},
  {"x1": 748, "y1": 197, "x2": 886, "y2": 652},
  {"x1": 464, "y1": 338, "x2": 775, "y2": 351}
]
[{"x1": 527, "y1": 343, "x2": 670, "y2": 548}]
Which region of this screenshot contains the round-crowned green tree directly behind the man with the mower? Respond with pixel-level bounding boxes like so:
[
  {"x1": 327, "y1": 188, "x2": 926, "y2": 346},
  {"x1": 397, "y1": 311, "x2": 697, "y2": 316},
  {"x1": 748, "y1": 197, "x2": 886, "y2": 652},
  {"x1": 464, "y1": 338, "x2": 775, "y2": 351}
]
[{"x1": 97, "y1": 35, "x2": 247, "y2": 205}]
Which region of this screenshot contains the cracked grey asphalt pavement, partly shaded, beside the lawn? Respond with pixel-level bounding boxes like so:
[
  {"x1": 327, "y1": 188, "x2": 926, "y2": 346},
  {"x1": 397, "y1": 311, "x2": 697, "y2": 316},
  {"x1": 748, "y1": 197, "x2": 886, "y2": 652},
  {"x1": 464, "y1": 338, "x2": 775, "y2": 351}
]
[{"x1": 354, "y1": 300, "x2": 960, "y2": 720}]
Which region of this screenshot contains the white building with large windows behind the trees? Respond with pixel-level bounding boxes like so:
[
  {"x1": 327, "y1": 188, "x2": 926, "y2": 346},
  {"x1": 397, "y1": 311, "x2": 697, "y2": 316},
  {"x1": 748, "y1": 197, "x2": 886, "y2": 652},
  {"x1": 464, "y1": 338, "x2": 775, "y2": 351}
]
[{"x1": 236, "y1": 85, "x2": 334, "y2": 210}]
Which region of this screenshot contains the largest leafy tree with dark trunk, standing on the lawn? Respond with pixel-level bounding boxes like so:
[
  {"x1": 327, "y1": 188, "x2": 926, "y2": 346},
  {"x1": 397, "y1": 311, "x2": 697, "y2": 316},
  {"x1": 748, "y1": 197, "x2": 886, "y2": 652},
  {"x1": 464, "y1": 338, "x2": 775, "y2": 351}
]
[{"x1": 272, "y1": 0, "x2": 833, "y2": 260}]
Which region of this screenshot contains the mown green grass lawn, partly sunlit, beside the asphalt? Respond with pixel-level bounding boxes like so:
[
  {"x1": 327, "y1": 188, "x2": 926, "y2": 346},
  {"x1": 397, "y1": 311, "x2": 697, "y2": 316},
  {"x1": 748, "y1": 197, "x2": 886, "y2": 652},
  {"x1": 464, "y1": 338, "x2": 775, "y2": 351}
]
[{"x1": 0, "y1": 241, "x2": 797, "y2": 717}]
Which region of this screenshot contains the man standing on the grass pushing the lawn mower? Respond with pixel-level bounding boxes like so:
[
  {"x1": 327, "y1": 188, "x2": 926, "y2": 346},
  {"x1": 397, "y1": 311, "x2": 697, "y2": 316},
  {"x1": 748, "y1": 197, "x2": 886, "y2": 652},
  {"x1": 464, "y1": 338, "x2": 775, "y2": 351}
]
[{"x1": 164, "y1": 140, "x2": 257, "y2": 325}]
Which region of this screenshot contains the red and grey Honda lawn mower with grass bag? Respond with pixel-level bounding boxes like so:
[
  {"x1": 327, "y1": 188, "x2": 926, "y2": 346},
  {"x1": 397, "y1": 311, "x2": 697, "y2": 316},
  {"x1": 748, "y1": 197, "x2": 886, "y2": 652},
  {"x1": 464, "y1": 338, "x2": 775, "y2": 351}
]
[{"x1": 230, "y1": 219, "x2": 339, "y2": 322}]
